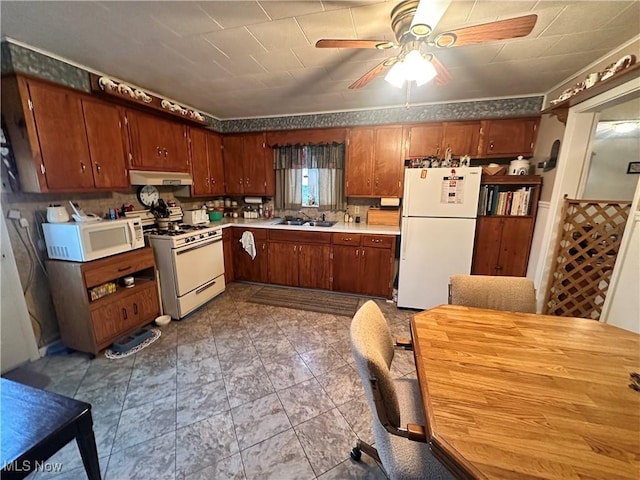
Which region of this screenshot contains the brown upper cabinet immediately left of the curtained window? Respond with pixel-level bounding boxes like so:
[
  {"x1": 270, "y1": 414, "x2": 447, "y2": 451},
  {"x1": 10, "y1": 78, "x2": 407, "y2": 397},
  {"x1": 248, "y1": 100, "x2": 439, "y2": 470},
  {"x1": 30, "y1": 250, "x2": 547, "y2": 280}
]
[{"x1": 222, "y1": 133, "x2": 275, "y2": 196}]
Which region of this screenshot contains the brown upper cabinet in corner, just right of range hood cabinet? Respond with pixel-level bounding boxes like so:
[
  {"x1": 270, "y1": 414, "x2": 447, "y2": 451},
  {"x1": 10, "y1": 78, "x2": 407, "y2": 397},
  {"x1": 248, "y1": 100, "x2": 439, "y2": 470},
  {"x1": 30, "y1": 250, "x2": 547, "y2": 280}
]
[{"x1": 189, "y1": 128, "x2": 225, "y2": 197}]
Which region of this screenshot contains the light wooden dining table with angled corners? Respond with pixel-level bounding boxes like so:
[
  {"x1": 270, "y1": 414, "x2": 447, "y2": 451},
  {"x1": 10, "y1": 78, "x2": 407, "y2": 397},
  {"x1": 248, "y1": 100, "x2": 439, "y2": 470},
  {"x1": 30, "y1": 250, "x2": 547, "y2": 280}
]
[{"x1": 411, "y1": 305, "x2": 640, "y2": 480}]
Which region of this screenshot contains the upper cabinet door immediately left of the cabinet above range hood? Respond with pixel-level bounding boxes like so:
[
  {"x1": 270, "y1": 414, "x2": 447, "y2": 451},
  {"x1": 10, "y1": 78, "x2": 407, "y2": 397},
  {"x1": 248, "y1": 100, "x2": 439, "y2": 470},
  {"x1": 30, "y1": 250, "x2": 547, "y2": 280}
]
[{"x1": 82, "y1": 99, "x2": 130, "y2": 188}]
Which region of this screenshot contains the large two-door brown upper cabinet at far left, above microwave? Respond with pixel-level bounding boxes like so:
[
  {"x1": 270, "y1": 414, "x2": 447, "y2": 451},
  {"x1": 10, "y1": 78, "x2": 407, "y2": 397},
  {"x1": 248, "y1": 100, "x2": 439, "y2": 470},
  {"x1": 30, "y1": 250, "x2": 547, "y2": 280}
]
[{"x1": 2, "y1": 76, "x2": 129, "y2": 192}]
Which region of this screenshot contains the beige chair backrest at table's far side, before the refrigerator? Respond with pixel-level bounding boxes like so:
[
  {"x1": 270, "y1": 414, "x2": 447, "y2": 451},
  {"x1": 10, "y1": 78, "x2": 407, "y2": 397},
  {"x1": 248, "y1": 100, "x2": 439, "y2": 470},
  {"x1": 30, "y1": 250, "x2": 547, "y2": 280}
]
[{"x1": 449, "y1": 275, "x2": 536, "y2": 313}]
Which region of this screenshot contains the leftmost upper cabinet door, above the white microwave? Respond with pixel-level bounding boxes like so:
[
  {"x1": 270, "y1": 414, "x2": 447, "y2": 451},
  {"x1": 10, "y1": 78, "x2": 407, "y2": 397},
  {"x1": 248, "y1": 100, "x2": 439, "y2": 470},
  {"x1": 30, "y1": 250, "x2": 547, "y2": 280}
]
[{"x1": 28, "y1": 81, "x2": 92, "y2": 190}]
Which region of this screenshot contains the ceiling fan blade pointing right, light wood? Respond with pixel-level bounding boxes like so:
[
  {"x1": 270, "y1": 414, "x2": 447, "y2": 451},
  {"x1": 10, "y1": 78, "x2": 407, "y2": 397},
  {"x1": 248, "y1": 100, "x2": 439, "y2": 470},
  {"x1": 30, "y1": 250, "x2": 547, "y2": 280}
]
[{"x1": 434, "y1": 15, "x2": 538, "y2": 47}]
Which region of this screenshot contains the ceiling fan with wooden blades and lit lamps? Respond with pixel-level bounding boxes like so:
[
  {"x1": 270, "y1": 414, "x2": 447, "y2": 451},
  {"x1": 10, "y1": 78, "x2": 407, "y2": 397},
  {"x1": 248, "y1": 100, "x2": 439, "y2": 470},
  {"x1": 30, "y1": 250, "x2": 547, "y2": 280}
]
[{"x1": 316, "y1": 0, "x2": 538, "y2": 89}]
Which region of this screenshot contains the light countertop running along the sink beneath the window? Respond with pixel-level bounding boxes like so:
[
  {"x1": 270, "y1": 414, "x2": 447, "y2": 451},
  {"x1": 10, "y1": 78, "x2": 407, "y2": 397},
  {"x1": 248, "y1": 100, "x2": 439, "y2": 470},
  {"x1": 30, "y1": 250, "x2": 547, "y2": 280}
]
[{"x1": 202, "y1": 218, "x2": 400, "y2": 235}]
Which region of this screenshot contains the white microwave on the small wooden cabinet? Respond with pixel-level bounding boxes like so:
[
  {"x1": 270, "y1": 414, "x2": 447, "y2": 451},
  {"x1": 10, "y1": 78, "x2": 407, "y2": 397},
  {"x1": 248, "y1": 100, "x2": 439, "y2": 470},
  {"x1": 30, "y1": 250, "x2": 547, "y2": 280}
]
[{"x1": 42, "y1": 218, "x2": 144, "y2": 262}]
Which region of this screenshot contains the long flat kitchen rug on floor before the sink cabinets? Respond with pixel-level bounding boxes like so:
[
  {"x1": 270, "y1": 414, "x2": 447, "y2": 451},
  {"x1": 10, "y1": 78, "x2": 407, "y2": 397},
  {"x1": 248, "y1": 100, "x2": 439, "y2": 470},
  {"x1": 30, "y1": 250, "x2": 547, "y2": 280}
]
[{"x1": 248, "y1": 287, "x2": 360, "y2": 317}]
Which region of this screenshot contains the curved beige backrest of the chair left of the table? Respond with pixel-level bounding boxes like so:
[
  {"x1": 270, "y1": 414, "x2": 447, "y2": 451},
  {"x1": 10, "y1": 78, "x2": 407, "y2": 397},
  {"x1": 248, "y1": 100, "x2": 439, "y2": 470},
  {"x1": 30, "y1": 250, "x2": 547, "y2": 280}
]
[{"x1": 350, "y1": 300, "x2": 400, "y2": 428}]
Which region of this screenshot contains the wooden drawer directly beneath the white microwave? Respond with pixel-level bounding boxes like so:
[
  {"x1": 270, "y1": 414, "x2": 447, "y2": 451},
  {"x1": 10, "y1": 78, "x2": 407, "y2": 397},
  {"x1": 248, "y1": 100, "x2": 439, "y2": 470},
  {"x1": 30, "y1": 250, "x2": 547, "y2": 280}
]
[{"x1": 82, "y1": 248, "x2": 154, "y2": 288}]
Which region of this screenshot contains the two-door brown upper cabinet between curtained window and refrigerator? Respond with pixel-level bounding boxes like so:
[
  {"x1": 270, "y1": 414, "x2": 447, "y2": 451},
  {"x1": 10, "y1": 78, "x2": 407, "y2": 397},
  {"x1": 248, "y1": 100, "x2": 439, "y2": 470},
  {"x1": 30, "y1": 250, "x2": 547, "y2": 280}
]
[{"x1": 345, "y1": 126, "x2": 404, "y2": 197}]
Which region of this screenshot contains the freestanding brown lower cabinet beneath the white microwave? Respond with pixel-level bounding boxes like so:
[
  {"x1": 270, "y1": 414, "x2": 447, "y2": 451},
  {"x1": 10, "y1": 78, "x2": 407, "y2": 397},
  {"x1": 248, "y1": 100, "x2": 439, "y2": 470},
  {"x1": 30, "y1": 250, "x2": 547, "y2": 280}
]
[{"x1": 47, "y1": 248, "x2": 160, "y2": 355}]
